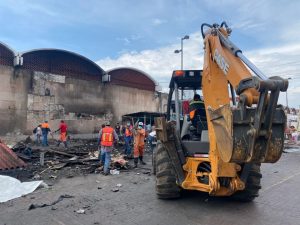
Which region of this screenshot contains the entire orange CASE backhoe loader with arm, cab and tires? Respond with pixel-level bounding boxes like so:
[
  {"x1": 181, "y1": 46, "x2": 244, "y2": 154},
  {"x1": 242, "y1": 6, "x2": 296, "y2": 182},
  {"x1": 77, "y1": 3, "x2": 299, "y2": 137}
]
[{"x1": 153, "y1": 22, "x2": 288, "y2": 201}]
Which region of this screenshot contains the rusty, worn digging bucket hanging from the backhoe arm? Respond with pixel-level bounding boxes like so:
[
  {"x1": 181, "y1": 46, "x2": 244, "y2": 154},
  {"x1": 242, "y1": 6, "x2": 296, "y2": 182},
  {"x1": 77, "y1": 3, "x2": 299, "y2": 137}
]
[{"x1": 208, "y1": 105, "x2": 286, "y2": 163}]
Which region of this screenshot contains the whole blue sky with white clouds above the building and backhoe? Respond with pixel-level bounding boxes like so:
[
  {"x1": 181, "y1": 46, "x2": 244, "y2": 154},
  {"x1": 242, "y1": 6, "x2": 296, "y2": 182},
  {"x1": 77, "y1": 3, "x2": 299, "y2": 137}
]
[{"x1": 0, "y1": 0, "x2": 300, "y2": 107}]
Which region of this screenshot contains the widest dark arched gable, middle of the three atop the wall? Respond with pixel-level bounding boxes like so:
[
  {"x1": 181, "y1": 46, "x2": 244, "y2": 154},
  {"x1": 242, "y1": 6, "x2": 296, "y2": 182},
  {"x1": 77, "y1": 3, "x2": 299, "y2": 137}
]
[{"x1": 20, "y1": 49, "x2": 105, "y2": 80}]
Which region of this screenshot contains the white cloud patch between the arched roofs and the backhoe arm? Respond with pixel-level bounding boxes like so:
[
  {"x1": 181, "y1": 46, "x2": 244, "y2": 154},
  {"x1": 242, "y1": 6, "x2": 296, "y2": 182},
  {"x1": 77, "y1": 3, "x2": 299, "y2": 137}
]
[{"x1": 97, "y1": 33, "x2": 202, "y2": 84}]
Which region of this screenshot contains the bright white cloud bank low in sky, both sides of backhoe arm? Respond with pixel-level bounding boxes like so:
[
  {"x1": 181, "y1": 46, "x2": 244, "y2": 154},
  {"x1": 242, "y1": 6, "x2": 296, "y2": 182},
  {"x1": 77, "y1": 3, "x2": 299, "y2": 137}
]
[{"x1": 97, "y1": 32, "x2": 300, "y2": 107}]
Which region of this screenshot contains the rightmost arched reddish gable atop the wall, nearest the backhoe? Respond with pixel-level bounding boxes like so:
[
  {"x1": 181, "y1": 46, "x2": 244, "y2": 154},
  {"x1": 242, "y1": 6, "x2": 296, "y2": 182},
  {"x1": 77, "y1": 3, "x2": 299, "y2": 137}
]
[{"x1": 107, "y1": 67, "x2": 158, "y2": 91}]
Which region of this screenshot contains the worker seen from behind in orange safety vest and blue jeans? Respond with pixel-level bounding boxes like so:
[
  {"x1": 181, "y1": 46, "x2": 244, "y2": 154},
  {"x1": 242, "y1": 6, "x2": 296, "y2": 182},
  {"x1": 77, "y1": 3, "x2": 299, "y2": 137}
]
[{"x1": 99, "y1": 122, "x2": 119, "y2": 176}]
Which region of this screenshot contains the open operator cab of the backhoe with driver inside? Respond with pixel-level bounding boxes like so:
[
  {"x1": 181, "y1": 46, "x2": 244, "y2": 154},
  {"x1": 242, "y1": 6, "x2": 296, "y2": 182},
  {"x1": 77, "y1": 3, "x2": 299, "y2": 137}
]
[{"x1": 167, "y1": 70, "x2": 209, "y2": 157}]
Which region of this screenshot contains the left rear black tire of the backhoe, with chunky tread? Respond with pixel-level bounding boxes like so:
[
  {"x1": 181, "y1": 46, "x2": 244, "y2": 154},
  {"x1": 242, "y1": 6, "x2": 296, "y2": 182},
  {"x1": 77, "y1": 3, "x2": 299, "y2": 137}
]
[{"x1": 155, "y1": 144, "x2": 181, "y2": 199}]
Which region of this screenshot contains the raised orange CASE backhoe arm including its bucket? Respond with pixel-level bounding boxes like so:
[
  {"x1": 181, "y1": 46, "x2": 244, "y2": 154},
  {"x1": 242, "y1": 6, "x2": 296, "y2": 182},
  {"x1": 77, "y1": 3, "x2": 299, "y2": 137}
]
[{"x1": 201, "y1": 22, "x2": 288, "y2": 163}]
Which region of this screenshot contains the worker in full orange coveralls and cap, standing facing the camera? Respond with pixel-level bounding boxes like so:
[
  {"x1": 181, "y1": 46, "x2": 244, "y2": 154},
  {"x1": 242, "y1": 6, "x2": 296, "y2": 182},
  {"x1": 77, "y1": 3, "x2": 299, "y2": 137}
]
[{"x1": 133, "y1": 122, "x2": 146, "y2": 168}]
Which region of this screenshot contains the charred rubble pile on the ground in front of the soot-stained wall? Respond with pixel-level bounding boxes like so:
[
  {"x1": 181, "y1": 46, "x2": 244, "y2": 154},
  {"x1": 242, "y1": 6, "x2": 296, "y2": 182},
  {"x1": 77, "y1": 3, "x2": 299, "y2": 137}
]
[{"x1": 0, "y1": 139, "x2": 130, "y2": 183}]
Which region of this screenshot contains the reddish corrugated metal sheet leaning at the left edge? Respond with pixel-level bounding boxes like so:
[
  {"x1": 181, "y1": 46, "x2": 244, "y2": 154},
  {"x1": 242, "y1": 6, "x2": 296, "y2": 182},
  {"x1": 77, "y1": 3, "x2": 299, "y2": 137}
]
[{"x1": 0, "y1": 141, "x2": 26, "y2": 170}]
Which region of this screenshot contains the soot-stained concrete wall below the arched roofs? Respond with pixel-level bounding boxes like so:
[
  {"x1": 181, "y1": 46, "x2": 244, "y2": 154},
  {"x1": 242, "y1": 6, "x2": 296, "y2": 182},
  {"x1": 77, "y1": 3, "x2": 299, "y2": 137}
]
[{"x1": 0, "y1": 66, "x2": 166, "y2": 135}]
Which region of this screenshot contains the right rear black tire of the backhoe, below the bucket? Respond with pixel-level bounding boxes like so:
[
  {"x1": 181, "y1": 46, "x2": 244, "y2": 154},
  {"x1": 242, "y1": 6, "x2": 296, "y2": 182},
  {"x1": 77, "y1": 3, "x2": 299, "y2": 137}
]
[{"x1": 232, "y1": 163, "x2": 262, "y2": 202}]
